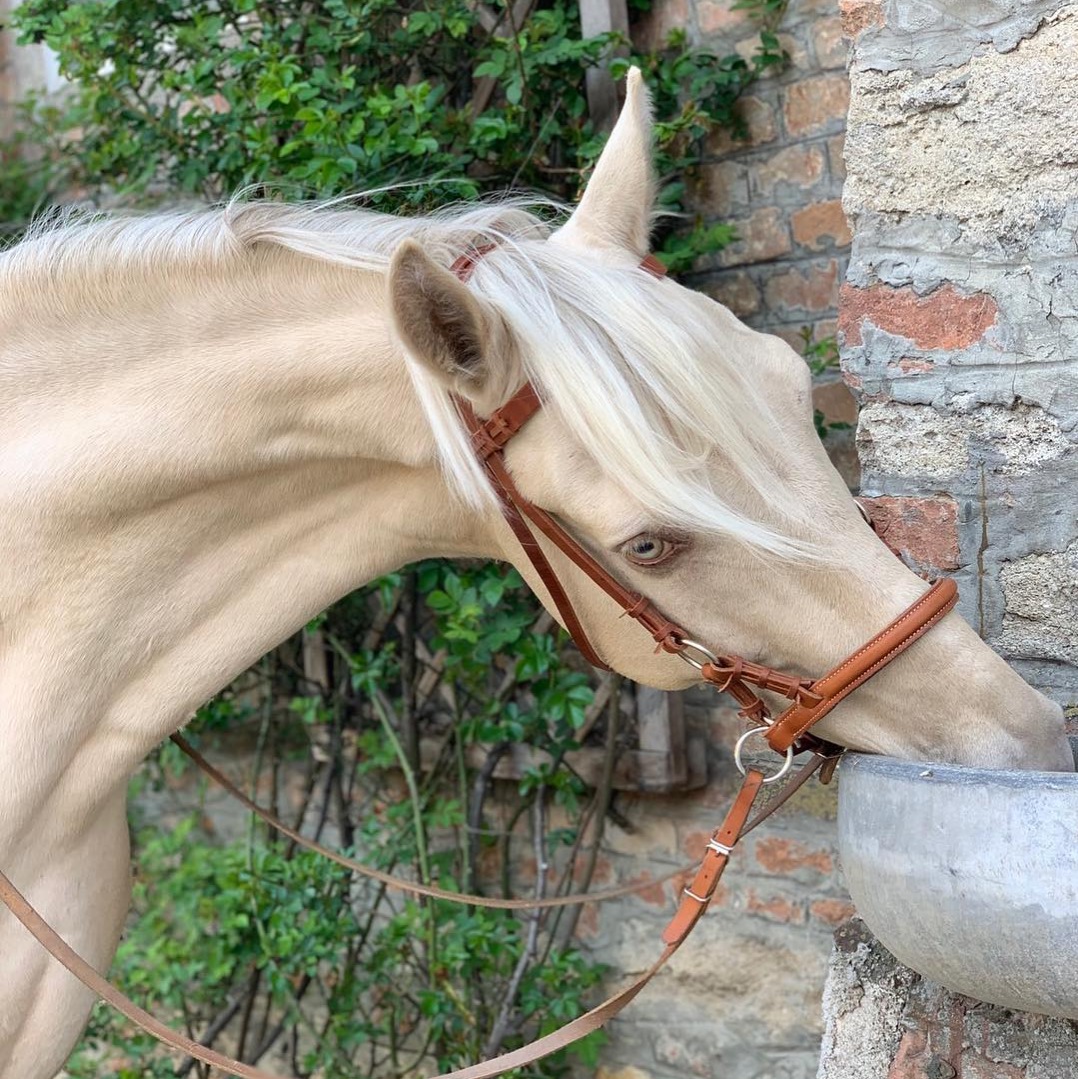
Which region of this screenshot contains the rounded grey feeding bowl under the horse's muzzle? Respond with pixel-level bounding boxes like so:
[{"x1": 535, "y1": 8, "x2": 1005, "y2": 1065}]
[{"x1": 838, "y1": 740, "x2": 1078, "y2": 1019}]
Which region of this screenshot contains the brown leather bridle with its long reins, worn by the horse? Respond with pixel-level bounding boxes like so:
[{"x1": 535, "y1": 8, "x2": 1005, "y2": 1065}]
[{"x1": 0, "y1": 246, "x2": 958, "y2": 1079}]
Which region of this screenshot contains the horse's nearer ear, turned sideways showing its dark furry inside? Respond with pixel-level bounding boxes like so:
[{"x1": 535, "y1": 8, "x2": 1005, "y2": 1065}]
[{"x1": 387, "y1": 240, "x2": 516, "y2": 400}]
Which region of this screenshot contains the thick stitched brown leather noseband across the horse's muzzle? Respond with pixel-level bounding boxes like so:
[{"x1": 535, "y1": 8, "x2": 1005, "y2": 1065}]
[{"x1": 767, "y1": 577, "x2": 958, "y2": 753}]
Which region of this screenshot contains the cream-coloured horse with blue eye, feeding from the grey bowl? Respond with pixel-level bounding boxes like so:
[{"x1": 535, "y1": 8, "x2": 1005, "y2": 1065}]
[{"x1": 0, "y1": 71, "x2": 1073, "y2": 1079}]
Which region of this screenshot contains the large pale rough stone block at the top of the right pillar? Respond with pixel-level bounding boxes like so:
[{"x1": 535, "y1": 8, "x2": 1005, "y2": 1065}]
[{"x1": 845, "y1": 4, "x2": 1078, "y2": 236}]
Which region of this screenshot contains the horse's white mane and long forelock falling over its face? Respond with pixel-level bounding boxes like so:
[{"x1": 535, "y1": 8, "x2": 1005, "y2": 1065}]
[{"x1": 0, "y1": 200, "x2": 814, "y2": 558}]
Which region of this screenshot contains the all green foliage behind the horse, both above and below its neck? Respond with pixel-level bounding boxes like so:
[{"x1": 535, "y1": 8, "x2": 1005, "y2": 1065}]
[{"x1": 0, "y1": 0, "x2": 830, "y2": 1079}]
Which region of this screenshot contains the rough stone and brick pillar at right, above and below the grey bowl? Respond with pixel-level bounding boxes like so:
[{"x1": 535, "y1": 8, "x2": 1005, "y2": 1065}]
[{"x1": 820, "y1": 0, "x2": 1078, "y2": 1079}]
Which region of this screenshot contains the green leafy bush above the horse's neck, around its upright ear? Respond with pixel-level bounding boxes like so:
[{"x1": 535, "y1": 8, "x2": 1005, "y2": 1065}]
[{"x1": 6, "y1": 0, "x2": 784, "y2": 256}]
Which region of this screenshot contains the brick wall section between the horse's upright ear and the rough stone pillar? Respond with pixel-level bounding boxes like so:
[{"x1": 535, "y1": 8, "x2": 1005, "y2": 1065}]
[{"x1": 640, "y1": 0, "x2": 849, "y2": 345}]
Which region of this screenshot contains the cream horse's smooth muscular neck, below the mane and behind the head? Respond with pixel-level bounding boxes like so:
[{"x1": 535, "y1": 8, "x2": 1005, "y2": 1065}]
[{"x1": 0, "y1": 252, "x2": 490, "y2": 817}]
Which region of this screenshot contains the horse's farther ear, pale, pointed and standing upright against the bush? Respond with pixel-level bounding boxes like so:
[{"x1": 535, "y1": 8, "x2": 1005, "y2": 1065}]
[{"x1": 554, "y1": 68, "x2": 655, "y2": 261}]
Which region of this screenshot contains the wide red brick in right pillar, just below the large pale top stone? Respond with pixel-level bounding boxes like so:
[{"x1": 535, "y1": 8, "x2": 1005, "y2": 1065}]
[{"x1": 838, "y1": 285, "x2": 999, "y2": 352}]
